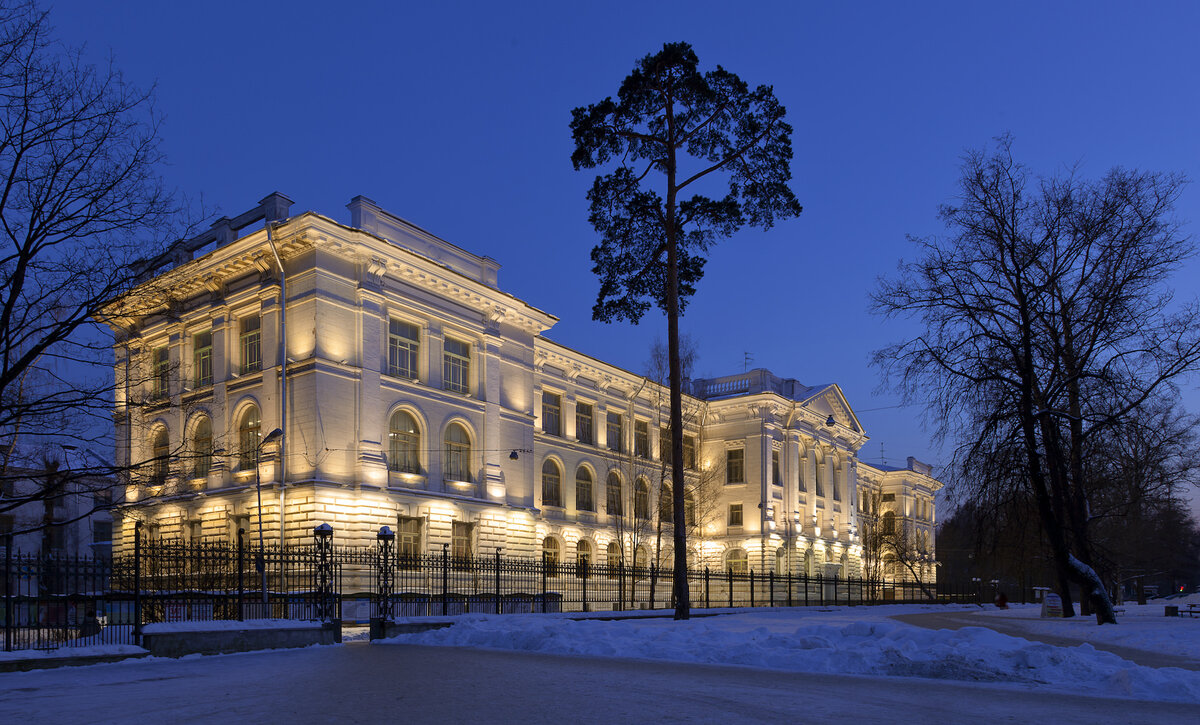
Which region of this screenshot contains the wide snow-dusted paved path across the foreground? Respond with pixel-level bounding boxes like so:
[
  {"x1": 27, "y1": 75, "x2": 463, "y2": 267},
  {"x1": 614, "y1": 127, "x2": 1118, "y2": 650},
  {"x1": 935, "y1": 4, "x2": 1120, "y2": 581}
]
[{"x1": 0, "y1": 643, "x2": 1196, "y2": 725}]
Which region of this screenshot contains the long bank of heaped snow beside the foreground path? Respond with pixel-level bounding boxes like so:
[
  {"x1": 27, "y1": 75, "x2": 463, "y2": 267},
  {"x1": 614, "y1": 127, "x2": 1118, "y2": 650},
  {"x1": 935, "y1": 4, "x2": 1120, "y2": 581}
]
[{"x1": 388, "y1": 607, "x2": 1200, "y2": 702}]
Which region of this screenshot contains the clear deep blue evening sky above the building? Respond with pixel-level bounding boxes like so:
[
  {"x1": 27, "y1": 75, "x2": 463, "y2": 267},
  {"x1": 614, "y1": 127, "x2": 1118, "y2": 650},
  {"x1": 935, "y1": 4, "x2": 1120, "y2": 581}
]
[{"x1": 47, "y1": 0, "x2": 1200, "y2": 499}]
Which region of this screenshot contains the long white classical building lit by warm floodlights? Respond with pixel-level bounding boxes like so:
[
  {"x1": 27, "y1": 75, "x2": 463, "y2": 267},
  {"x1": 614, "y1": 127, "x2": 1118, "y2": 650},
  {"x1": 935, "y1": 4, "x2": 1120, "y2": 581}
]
[{"x1": 107, "y1": 194, "x2": 938, "y2": 576}]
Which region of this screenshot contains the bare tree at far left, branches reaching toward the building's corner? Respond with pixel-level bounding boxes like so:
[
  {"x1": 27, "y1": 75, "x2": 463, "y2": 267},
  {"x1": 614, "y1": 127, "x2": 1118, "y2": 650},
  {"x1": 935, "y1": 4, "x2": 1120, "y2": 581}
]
[{"x1": 0, "y1": 2, "x2": 182, "y2": 537}]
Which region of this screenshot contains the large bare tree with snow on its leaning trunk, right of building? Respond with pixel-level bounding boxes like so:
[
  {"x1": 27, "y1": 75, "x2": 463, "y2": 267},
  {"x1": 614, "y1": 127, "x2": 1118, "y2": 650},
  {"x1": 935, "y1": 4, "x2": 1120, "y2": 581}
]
[{"x1": 874, "y1": 137, "x2": 1200, "y2": 622}]
